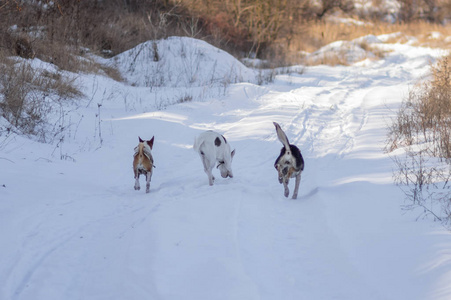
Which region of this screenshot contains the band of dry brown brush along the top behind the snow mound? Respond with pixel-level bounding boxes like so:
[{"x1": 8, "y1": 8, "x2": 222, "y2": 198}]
[{"x1": 0, "y1": 0, "x2": 451, "y2": 72}]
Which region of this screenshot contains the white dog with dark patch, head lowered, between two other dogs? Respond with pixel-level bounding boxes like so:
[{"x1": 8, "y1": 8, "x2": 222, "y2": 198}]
[{"x1": 193, "y1": 130, "x2": 235, "y2": 185}]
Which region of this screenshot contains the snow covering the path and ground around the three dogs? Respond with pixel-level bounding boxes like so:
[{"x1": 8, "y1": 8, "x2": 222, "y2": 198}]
[{"x1": 0, "y1": 35, "x2": 451, "y2": 300}]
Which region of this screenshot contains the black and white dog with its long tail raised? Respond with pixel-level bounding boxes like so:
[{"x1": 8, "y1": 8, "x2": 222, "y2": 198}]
[{"x1": 273, "y1": 122, "x2": 304, "y2": 199}]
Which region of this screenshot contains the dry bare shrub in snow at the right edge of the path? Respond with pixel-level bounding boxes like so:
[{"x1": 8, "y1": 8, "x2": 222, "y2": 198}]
[{"x1": 386, "y1": 56, "x2": 451, "y2": 228}]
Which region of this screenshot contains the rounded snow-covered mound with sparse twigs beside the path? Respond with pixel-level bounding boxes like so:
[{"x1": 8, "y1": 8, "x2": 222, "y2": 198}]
[{"x1": 112, "y1": 37, "x2": 255, "y2": 87}]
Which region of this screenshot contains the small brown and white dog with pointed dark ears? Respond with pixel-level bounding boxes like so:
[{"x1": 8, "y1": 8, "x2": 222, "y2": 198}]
[{"x1": 133, "y1": 137, "x2": 154, "y2": 193}]
